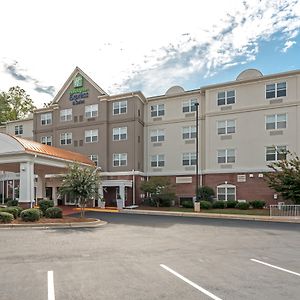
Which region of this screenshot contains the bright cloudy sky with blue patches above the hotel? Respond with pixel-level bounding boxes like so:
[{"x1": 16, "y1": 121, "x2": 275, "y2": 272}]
[{"x1": 0, "y1": 0, "x2": 300, "y2": 107}]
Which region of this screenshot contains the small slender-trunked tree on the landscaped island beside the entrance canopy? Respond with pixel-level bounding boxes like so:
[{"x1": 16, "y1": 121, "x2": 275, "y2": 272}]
[{"x1": 59, "y1": 163, "x2": 100, "y2": 218}]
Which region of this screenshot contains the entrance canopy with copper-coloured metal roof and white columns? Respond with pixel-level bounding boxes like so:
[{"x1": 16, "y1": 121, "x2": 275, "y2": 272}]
[{"x1": 0, "y1": 133, "x2": 94, "y2": 207}]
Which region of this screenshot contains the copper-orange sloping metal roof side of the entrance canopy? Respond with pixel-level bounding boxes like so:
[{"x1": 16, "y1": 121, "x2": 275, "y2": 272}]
[{"x1": 12, "y1": 136, "x2": 95, "y2": 166}]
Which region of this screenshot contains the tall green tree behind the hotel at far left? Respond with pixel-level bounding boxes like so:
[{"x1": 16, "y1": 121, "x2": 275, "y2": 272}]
[{"x1": 0, "y1": 86, "x2": 36, "y2": 122}]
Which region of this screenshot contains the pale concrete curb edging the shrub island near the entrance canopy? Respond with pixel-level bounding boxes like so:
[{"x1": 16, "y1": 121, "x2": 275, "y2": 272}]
[{"x1": 0, "y1": 220, "x2": 107, "y2": 229}]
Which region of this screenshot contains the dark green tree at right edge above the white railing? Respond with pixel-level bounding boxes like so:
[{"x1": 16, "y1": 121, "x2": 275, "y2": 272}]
[{"x1": 265, "y1": 151, "x2": 300, "y2": 204}]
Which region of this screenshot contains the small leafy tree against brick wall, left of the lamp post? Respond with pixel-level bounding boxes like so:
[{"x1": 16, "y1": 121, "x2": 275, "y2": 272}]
[{"x1": 141, "y1": 177, "x2": 176, "y2": 207}]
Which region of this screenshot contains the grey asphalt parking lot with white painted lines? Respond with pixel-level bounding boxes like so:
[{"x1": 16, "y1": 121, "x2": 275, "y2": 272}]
[{"x1": 0, "y1": 213, "x2": 300, "y2": 300}]
